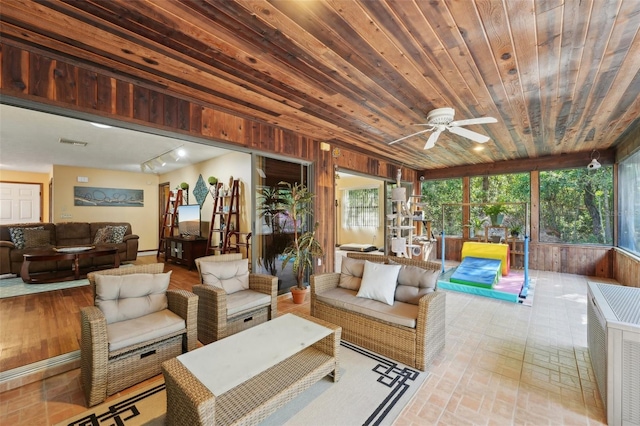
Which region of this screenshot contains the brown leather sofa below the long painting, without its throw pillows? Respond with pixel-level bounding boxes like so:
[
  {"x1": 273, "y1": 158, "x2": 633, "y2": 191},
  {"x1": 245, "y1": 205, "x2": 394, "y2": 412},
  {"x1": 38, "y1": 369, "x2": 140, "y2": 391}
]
[{"x1": 0, "y1": 222, "x2": 139, "y2": 275}]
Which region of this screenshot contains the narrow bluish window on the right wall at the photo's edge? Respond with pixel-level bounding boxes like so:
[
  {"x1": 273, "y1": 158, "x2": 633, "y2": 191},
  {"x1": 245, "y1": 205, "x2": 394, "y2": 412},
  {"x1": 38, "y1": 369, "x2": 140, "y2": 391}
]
[{"x1": 618, "y1": 151, "x2": 640, "y2": 256}]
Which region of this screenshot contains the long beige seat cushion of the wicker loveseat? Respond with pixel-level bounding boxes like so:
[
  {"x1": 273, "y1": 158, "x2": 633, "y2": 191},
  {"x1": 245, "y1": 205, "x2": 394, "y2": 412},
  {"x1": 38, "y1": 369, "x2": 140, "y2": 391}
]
[{"x1": 316, "y1": 287, "x2": 418, "y2": 328}]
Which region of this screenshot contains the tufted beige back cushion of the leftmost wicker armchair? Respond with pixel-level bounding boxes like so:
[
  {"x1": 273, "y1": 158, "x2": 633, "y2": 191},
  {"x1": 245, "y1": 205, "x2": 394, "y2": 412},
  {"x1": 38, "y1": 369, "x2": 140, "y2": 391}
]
[{"x1": 95, "y1": 271, "x2": 171, "y2": 324}]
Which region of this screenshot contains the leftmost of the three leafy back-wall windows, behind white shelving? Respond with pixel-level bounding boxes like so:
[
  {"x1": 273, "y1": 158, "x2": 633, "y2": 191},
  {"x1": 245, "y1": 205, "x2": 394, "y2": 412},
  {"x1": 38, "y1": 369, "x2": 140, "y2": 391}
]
[{"x1": 421, "y1": 179, "x2": 462, "y2": 236}]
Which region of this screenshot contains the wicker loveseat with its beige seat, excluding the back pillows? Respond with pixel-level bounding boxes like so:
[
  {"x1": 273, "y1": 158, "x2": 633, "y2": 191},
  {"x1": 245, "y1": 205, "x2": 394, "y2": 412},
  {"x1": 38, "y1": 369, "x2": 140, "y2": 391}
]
[{"x1": 311, "y1": 253, "x2": 446, "y2": 371}]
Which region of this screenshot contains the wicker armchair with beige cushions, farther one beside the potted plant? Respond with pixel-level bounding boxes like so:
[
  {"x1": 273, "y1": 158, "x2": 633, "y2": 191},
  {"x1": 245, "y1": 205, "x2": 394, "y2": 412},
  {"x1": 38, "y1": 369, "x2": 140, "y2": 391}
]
[{"x1": 193, "y1": 253, "x2": 278, "y2": 345}]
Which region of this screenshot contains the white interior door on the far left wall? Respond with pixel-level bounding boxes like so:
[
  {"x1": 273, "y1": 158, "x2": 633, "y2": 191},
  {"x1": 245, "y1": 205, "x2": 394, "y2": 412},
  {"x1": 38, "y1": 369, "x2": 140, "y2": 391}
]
[{"x1": 0, "y1": 183, "x2": 42, "y2": 225}]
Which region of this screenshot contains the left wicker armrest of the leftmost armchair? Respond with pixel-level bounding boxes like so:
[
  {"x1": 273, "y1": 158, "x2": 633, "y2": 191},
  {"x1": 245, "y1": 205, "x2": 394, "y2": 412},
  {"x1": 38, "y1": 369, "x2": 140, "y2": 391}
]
[{"x1": 80, "y1": 306, "x2": 109, "y2": 407}]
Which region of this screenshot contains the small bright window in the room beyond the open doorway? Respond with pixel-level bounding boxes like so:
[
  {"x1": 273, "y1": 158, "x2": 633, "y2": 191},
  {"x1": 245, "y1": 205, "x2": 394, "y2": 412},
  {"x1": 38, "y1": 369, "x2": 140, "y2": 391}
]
[{"x1": 343, "y1": 188, "x2": 380, "y2": 228}]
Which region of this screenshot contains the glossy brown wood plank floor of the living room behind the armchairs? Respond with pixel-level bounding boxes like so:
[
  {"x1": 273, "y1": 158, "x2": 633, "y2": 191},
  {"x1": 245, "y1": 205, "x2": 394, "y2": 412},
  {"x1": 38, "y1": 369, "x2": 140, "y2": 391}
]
[{"x1": 0, "y1": 256, "x2": 198, "y2": 371}]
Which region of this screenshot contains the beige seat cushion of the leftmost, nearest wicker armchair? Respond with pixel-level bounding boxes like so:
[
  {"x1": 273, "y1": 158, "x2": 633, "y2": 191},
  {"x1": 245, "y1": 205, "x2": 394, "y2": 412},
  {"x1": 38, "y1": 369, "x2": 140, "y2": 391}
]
[{"x1": 107, "y1": 309, "x2": 187, "y2": 352}]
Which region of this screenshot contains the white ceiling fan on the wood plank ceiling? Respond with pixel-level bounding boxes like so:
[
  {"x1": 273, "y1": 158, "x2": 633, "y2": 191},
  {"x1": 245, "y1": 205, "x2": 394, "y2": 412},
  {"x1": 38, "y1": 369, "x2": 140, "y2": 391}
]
[{"x1": 389, "y1": 108, "x2": 498, "y2": 149}]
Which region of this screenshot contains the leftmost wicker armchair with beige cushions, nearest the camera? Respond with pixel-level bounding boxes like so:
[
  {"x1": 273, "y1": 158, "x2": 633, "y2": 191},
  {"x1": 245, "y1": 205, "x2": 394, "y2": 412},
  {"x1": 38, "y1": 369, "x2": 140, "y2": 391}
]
[{"x1": 80, "y1": 263, "x2": 198, "y2": 407}]
